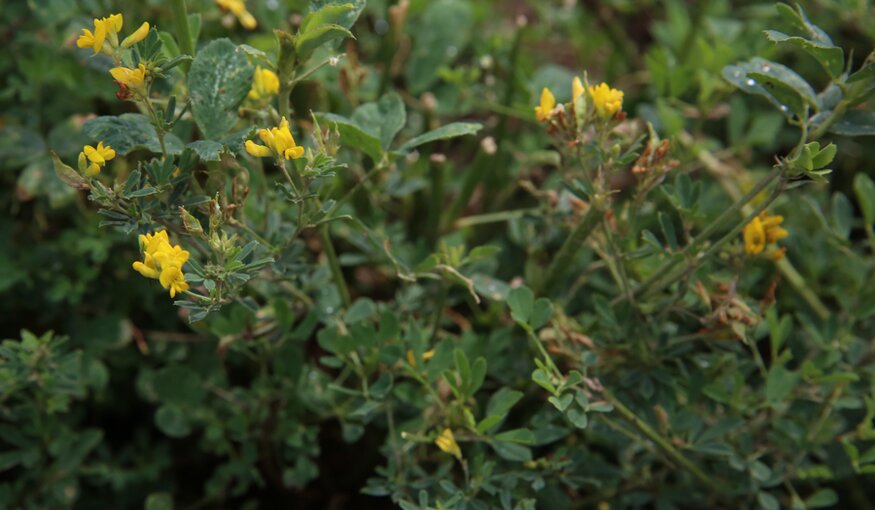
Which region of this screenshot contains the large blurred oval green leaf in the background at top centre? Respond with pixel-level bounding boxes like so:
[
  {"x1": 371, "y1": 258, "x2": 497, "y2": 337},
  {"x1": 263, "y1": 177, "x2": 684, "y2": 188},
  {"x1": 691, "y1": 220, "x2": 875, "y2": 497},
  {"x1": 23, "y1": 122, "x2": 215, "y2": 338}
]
[{"x1": 405, "y1": 0, "x2": 474, "y2": 95}]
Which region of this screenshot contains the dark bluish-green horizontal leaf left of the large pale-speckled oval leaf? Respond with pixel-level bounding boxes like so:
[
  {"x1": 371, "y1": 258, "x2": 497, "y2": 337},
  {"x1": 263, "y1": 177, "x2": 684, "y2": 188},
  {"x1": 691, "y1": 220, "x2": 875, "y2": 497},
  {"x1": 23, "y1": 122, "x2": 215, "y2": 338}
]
[{"x1": 82, "y1": 113, "x2": 184, "y2": 156}]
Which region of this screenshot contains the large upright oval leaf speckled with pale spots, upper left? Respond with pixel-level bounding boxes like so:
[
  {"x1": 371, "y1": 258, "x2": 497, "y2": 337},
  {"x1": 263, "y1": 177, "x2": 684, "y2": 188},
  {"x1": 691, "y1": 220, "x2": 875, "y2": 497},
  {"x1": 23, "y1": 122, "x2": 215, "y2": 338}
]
[{"x1": 188, "y1": 39, "x2": 254, "y2": 138}]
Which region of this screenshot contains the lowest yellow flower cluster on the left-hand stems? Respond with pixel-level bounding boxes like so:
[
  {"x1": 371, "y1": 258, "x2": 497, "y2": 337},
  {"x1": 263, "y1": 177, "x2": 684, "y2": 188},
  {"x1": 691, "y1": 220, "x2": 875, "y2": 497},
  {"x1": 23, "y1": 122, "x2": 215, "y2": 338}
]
[{"x1": 133, "y1": 230, "x2": 189, "y2": 297}]
